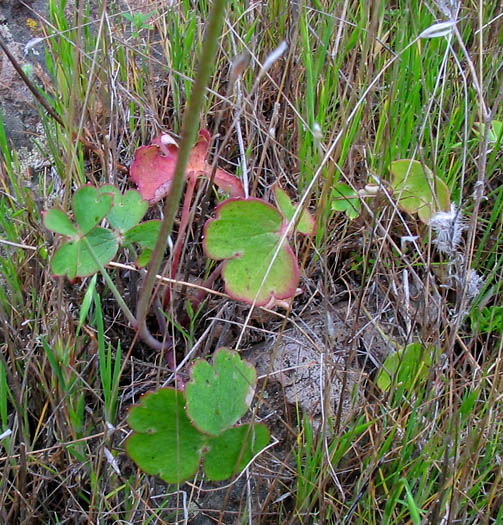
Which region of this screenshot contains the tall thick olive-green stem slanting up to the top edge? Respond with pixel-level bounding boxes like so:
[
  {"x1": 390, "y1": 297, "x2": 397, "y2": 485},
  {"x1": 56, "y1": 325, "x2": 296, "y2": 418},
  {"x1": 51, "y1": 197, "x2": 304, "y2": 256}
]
[{"x1": 136, "y1": 0, "x2": 225, "y2": 327}]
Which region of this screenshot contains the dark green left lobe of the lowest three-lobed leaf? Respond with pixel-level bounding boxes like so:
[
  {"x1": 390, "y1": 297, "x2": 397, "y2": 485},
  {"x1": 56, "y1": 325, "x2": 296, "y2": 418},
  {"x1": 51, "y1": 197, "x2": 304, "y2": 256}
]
[{"x1": 126, "y1": 388, "x2": 207, "y2": 483}]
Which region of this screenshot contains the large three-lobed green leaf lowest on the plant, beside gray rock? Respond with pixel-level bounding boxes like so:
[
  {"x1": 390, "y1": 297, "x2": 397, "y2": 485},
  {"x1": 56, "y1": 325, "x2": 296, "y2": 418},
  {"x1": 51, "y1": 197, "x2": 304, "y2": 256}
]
[{"x1": 126, "y1": 348, "x2": 269, "y2": 483}]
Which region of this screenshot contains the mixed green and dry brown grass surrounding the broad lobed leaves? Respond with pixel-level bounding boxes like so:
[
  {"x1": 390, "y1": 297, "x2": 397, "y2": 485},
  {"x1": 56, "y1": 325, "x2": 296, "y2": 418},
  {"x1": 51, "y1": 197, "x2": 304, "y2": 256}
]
[{"x1": 0, "y1": 0, "x2": 503, "y2": 524}]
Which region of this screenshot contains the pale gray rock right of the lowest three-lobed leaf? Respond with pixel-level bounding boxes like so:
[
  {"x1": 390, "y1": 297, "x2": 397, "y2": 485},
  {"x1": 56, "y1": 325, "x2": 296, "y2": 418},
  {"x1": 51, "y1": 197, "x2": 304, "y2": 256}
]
[{"x1": 243, "y1": 303, "x2": 389, "y2": 426}]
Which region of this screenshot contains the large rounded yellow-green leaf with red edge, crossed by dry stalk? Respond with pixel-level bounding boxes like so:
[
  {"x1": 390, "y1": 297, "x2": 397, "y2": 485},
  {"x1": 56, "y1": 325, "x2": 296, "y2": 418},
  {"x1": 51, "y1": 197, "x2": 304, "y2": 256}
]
[{"x1": 203, "y1": 198, "x2": 299, "y2": 306}]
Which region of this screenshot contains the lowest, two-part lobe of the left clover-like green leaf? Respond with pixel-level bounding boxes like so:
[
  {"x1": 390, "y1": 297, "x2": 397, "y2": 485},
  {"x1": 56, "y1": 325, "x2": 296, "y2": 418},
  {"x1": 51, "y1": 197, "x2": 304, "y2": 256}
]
[{"x1": 51, "y1": 227, "x2": 119, "y2": 280}]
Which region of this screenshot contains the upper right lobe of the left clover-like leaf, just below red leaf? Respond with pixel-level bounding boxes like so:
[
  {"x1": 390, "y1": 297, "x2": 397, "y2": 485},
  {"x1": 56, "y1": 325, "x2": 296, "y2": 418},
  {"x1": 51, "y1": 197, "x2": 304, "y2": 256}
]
[{"x1": 100, "y1": 184, "x2": 148, "y2": 233}]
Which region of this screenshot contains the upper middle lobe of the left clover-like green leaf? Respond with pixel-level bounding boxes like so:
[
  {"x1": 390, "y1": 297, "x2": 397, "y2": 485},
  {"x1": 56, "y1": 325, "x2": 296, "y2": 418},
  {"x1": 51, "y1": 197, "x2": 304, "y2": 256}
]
[{"x1": 73, "y1": 186, "x2": 113, "y2": 235}]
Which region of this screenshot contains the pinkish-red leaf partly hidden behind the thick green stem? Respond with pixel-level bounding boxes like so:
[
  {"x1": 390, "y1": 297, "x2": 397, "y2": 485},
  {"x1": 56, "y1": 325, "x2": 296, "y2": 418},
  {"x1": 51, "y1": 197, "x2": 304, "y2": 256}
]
[{"x1": 129, "y1": 129, "x2": 244, "y2": 204}]
